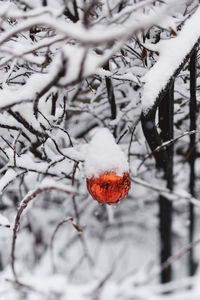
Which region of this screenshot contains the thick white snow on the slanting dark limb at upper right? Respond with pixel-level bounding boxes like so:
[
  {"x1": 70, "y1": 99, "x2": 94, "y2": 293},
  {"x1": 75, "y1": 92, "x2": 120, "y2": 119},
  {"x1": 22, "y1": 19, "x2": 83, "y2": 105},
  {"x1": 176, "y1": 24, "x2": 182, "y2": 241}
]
[{"x1": 142, "y1": 7, "x2": 200, "y2": 114}]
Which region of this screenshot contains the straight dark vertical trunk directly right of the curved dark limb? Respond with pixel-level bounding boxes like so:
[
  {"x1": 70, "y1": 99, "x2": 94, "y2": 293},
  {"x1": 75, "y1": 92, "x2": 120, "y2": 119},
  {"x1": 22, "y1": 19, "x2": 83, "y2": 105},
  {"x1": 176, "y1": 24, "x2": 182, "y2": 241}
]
[{"x1": 159, "y1": 81, "x2": 174, "y2": 283}]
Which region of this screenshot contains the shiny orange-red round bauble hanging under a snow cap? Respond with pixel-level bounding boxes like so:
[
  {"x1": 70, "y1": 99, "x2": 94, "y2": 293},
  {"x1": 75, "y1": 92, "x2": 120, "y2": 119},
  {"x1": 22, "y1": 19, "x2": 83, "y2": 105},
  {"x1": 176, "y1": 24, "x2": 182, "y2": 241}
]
[{"x1": 87, "y1": 173, "x2": 131, "y2": 204}]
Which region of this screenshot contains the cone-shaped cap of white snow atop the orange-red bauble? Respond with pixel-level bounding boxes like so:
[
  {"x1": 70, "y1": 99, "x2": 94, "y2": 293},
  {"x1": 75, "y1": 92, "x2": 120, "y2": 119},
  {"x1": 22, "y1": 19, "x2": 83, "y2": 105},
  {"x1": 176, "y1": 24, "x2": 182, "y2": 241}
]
[{"x1": 85, "y1": 128, "x2": 128, "y2": 178}]
